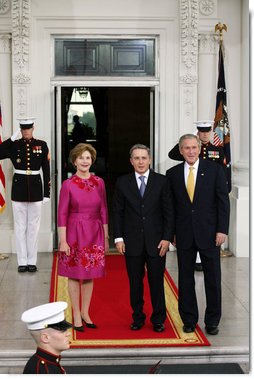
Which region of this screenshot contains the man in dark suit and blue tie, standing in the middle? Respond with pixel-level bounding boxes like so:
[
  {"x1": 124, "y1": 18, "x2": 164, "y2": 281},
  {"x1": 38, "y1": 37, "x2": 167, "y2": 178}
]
[{"x1": 113, "y1": 144, "x2": 173, "y2": 332}]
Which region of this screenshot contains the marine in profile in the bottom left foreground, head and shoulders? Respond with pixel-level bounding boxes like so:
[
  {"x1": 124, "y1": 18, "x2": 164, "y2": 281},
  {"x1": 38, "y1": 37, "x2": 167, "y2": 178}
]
[{"x1": 21, "y1": 301, "x2": 72, "y2": 374}]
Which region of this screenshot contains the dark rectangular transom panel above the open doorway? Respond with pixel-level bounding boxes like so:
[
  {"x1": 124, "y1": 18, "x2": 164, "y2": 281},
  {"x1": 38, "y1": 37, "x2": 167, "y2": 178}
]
[{"x1": 55, "y1": 38, "x2": 155, "y2": 76}]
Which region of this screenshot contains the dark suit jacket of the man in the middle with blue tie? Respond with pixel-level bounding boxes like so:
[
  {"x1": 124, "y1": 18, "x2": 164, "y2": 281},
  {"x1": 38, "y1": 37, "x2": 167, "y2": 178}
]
[{"x1": 113, "y1": 170, "x2": 173, "y2": 256}]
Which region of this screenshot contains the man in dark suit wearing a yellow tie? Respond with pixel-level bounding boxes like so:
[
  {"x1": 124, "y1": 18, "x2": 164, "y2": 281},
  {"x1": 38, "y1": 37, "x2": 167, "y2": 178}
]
[{"x1": 166, "y1": 134, "x2": 229, "y2": 335}]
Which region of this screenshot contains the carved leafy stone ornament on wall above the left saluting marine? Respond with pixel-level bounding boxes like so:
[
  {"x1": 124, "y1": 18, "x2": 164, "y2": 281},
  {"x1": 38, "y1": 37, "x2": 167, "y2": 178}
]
[{"x1": 12, "y1": 0, "x2": 30, "y2": 68}]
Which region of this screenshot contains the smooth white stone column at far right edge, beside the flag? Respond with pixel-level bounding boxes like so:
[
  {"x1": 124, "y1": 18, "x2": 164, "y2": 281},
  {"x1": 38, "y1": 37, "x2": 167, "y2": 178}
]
[{"x1": 230, "y1": 0, "x2": 249, "y2": 257}]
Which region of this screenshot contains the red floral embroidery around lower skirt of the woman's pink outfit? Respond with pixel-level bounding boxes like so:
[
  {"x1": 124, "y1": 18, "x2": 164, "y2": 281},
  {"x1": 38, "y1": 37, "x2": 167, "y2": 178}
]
[{"x1": 59, "y1": 243, "x2": 105, "y2": 271}]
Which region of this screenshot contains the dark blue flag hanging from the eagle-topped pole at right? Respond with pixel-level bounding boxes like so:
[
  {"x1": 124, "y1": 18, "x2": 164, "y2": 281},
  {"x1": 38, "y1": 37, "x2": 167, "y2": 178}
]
[{"x1": 213, "y1": 43, "x2": 232, "y2": 192}]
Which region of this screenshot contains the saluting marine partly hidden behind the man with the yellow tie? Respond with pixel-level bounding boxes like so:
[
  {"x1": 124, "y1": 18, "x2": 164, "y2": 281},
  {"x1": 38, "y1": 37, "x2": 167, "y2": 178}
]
[{"x1": 168, "y1": 120, "x2": 226, "y2": 271}]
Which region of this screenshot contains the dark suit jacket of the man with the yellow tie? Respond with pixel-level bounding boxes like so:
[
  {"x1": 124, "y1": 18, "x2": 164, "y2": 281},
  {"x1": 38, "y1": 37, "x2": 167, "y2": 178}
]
[{"x1": 166, "y1": 159, "x2": 230, "y2": 249}]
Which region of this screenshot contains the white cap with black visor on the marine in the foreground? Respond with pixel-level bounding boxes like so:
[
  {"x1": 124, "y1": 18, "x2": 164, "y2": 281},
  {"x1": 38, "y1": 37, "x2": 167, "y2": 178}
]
[{"x1": 21, "y1": 301, "x2": 72, "y2": 330}]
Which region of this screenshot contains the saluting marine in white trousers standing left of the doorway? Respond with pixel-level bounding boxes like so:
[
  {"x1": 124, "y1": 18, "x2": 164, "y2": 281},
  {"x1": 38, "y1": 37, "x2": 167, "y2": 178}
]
[{"x1": 0, "y1": 118, "x2": 50, "y2": 272}]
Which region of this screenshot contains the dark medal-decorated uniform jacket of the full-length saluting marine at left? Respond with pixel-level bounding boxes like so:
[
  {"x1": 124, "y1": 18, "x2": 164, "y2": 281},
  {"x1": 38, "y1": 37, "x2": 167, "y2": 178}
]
[{"x1": 0, "y1": 138, "x2": 50, "y2": 202}]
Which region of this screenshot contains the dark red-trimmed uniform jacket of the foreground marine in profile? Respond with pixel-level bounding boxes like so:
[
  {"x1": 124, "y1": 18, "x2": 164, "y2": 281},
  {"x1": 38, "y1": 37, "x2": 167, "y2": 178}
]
[{"x1": 23, "y1": 347, "x2": 66, "y2": 374}]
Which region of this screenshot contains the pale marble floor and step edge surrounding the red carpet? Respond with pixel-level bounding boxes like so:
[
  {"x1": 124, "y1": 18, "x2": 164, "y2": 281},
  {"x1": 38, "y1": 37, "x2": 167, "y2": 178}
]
[{"x1": 0, "y1": 251, "x2": 250, "y2": 374}]
